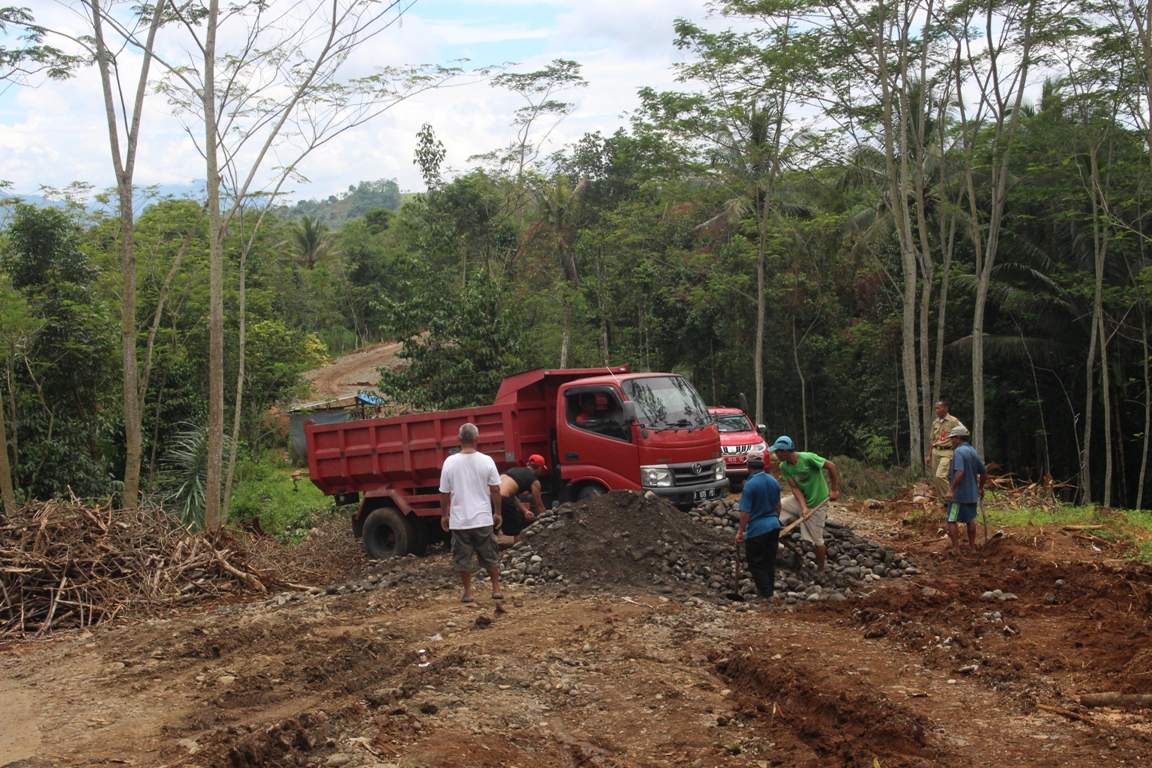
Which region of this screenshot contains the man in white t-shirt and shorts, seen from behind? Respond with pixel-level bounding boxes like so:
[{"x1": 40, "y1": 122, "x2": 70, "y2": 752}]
[{"x1": 440, "y1": 424, "x2": 503, "y2": 602}]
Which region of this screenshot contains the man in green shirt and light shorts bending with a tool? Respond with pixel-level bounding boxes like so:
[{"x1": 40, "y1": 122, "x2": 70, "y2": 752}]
[{"x1": 768, "y1": 435, "x2": 840, "y2": 573}]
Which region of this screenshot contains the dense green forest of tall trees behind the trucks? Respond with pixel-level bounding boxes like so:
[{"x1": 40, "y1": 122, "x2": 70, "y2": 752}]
[{"x1": 0, "y1": 0, "x2": 1152, "y2": 519}]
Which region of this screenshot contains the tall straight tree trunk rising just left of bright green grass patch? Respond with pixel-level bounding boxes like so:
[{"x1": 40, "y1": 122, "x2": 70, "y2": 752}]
[{"x1": 202, "y1": 0, "x2": 227, "y2": 531}]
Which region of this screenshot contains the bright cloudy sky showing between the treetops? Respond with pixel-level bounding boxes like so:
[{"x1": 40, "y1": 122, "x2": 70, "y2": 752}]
[{"x1": 0, "y1": 0, "x2": 707, "y2": 199}]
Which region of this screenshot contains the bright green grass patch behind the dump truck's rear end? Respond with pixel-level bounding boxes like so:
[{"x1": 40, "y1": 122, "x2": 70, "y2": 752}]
[{"x1": 229, "y1": 455, "x2": 336, "y2": 542}]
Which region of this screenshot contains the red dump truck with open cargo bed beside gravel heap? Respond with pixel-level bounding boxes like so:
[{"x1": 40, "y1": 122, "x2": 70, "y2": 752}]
[{"x1": 304, "y1": 365, "x2": 728, "y2": 560}]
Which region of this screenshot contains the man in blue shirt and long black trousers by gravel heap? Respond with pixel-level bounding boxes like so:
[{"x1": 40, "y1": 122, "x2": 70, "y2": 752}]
[{"x1": 736, "y1": 450, "x2": 780, "y2": 599}]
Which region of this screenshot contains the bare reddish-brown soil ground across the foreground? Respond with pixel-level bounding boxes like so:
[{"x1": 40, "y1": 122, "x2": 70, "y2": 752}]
[{"x1": 0, "y1": 502, "x2": 1152, "y2": 768}]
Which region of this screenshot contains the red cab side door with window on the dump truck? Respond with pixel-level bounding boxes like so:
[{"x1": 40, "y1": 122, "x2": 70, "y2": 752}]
[{"x1": 556, "y1": 385, "x2": 641, "y2": 491}]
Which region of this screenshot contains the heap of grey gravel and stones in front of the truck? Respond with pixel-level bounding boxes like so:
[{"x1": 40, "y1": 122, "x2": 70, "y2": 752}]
[{"x1": 500, "y1": 491, "x2": 919, "y2": 604}]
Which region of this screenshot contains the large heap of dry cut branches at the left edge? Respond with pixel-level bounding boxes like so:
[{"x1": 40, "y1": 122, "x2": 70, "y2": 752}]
[{"x1": 0, "y1": 501, "x2": 285, "y2": 637}]
